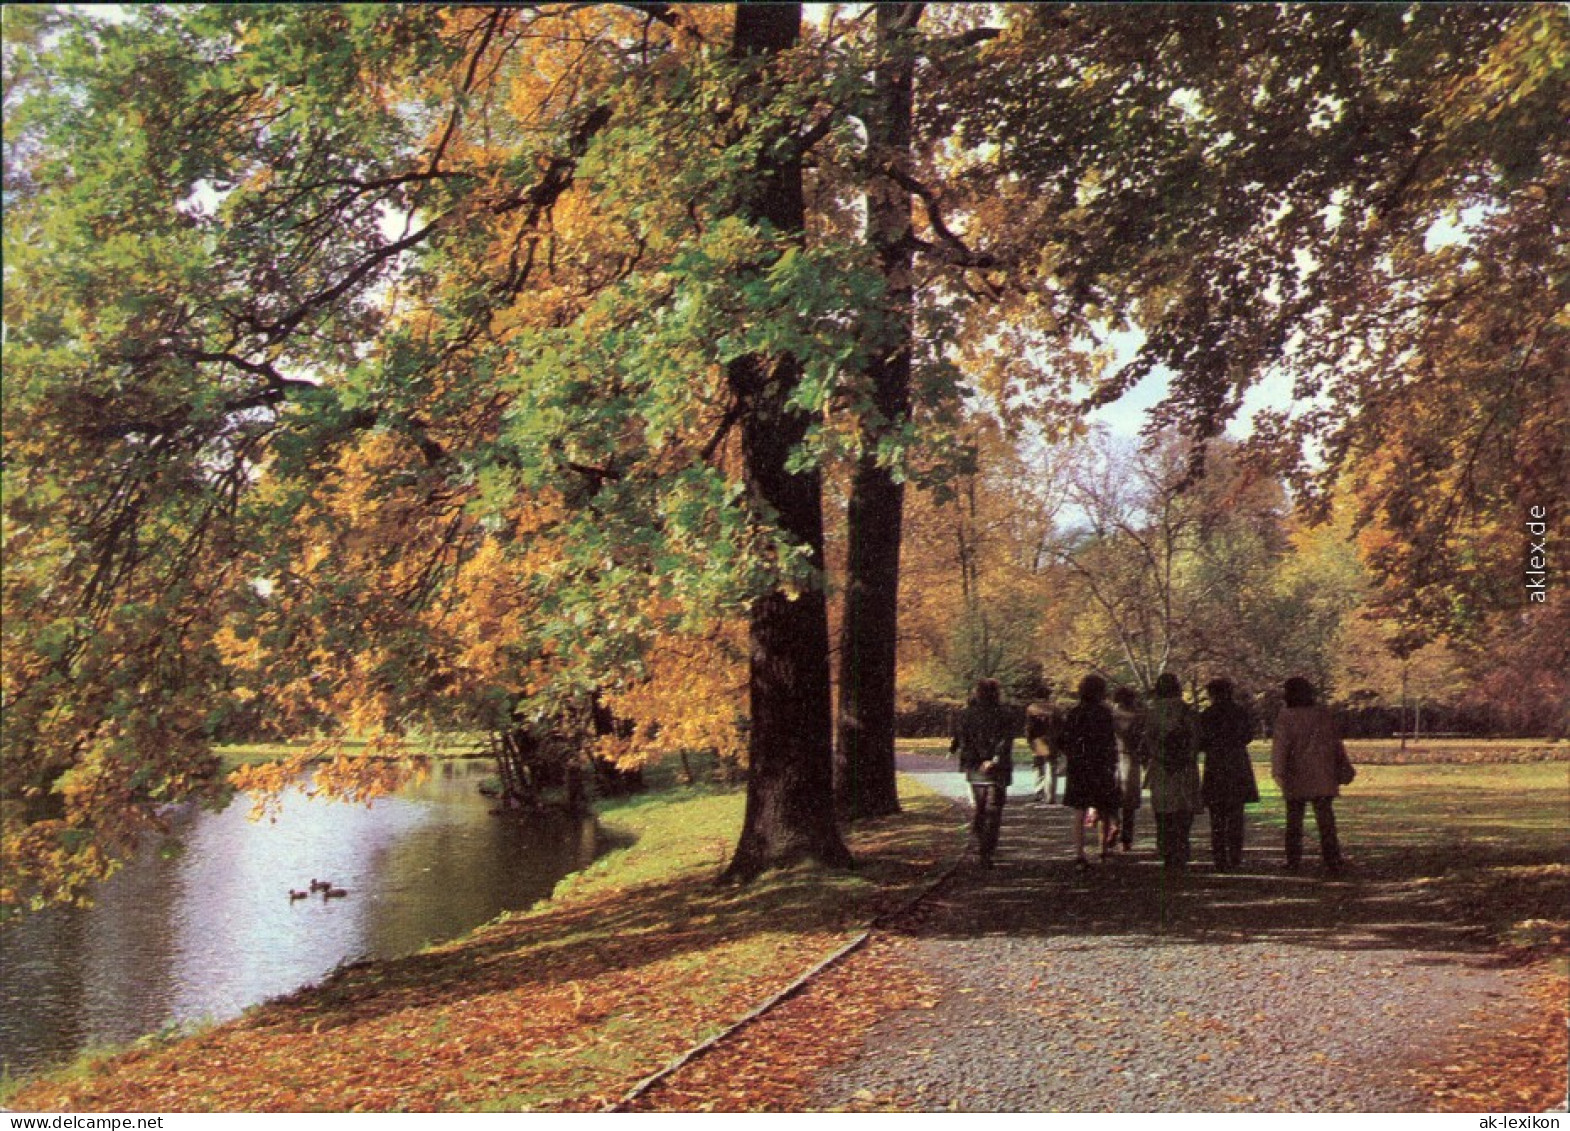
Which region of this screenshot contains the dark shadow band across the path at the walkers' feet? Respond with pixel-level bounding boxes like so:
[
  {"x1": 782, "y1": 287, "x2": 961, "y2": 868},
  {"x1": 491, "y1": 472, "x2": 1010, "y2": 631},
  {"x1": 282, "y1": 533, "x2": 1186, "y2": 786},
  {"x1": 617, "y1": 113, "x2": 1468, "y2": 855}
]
[{"x1": 889, "y1": 756, "x2": 1557, "y2": 961}]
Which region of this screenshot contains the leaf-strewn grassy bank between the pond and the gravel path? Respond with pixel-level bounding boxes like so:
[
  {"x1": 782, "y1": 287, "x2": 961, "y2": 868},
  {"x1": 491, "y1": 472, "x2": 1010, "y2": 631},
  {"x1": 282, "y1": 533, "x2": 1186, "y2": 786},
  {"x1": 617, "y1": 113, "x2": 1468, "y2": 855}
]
[{"x1": 5, "y1": 782, "x2": 964, "y2": 1112}]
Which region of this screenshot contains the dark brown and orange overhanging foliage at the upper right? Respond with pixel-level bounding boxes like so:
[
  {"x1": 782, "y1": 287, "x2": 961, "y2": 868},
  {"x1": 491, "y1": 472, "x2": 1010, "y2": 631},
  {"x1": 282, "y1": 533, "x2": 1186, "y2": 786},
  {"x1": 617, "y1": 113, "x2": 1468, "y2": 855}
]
[{"x1": 945, "y1": 5, "x2": 1570, "y2": 644}]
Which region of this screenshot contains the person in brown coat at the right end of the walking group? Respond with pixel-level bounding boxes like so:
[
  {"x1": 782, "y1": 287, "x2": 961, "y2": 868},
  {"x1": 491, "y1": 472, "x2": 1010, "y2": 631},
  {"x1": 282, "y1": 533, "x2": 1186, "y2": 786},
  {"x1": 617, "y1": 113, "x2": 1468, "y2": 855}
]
[{"x1": 1270, "y1": 675, "x2": 1345, "y2": 875}]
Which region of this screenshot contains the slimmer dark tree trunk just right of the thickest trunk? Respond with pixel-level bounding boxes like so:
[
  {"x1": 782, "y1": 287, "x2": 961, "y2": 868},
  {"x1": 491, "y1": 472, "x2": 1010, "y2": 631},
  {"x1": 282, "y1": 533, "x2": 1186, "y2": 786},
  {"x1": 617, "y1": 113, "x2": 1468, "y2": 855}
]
[{"x1": 835, "y1": 3, "x2": 925, "y2": 820}]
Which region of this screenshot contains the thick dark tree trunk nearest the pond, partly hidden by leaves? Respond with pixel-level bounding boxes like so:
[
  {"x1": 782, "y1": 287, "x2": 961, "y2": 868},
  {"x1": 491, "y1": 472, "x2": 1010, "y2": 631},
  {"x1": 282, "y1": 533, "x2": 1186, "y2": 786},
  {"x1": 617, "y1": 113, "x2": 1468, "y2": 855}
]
[{"x1": 724, "y1": 3, "x2": 851, "y2": 881}]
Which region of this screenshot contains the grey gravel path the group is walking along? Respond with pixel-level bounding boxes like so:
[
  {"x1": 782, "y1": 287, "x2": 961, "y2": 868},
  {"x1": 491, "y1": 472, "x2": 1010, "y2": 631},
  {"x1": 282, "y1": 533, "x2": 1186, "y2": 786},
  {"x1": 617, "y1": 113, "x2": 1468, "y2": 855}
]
[{"x1": 813, "y1": 759, "x2": 1523, "y2": 1112}]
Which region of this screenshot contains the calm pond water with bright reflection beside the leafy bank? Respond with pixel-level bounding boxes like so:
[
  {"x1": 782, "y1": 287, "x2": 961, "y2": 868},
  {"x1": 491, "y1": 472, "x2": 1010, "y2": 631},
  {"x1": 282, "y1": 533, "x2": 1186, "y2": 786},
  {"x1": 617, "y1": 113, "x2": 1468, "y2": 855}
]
[{"x1": 0, "y1": 762, "x2": 595, "y2": 1073}]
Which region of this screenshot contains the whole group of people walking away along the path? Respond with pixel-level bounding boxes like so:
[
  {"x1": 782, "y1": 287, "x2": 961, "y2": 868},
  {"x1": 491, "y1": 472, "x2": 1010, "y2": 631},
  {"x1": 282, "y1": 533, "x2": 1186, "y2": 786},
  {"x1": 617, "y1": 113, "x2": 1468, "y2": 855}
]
[{"x1": 951, "y1": 672, "x2": 1352, "y2": 873}]
